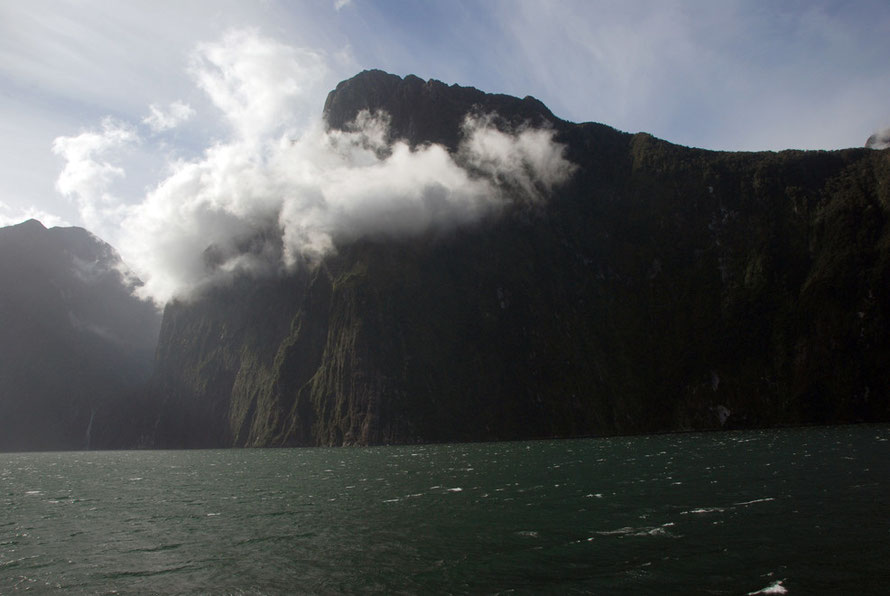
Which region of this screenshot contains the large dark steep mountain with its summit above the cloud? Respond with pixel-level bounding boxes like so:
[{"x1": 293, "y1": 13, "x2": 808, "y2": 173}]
[{"x1": 153, "y1": 71, "x2": 890, "y2": 447}]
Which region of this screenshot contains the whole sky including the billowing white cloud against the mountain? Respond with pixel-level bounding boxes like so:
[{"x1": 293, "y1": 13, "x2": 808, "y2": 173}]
[{"x1": 0, "y1": 0, "x2": 890, "y2": 301}]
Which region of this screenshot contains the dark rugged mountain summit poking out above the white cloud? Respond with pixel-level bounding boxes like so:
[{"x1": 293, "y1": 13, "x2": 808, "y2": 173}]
[{"x1": 324, "y1": 70, "x2": 558, "y2": 149}]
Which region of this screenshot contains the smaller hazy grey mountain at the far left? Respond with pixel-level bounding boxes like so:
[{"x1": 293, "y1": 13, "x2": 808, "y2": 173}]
[{"x1": 0, "y1": 220, "x2": 160, "y2": 451}]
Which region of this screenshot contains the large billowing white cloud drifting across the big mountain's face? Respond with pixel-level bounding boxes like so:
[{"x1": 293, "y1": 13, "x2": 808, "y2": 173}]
[{"x1": 54, "y1": 31, "x2": 573, "y2": 304}]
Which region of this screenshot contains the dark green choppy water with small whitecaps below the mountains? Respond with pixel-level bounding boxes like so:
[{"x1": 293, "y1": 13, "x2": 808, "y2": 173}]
[{"x1": 0, "y1": 426, "x2": 890, "y2": 594}]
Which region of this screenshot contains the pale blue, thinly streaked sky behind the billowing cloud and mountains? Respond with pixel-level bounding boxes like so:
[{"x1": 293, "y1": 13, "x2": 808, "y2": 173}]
[{"x1": 0, "y1": 0, "x2": 890, "y2": 235}]
